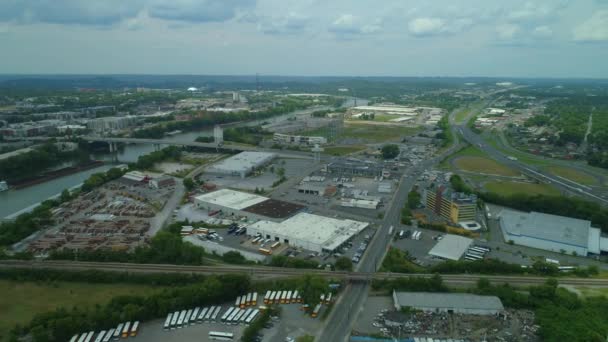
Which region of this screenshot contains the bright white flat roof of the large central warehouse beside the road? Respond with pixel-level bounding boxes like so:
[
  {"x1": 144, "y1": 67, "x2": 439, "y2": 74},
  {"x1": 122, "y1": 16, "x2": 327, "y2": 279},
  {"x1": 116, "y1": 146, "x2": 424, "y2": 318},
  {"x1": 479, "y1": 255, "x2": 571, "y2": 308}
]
[{"x1": 246, "y1": 213, "x2": 369, "y2": 250}]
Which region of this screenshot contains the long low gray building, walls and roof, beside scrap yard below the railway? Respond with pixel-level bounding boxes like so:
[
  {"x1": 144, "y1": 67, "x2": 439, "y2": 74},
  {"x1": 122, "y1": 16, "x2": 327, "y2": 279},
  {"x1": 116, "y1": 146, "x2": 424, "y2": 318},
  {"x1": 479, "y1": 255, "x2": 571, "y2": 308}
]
[{"x1": 393, "y1": 291, "x2": 504, "y2": 315}]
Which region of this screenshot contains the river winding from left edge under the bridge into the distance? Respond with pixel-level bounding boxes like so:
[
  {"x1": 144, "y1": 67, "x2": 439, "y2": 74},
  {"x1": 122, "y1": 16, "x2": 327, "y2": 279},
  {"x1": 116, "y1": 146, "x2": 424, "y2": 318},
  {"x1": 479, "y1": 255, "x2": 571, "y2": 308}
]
[{"x1": 0, "y1": 99, "x2": 367, "y2": 218}]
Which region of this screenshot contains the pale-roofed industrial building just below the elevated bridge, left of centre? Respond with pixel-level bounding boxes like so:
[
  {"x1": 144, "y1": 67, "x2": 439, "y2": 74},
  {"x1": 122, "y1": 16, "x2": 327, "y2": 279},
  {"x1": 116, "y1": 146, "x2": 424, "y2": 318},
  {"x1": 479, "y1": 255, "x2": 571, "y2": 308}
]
[{"x1": 206, "y1": 152, "x2": 276, "y2": 178}]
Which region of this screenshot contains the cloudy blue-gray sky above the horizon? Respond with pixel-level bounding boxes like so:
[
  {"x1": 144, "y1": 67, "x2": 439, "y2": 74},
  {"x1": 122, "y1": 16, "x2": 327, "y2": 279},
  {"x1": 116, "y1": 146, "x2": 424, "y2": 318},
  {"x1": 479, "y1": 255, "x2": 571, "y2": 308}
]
[{"x1": 0, "y1": 0, "x2": 608, "y2": 78}]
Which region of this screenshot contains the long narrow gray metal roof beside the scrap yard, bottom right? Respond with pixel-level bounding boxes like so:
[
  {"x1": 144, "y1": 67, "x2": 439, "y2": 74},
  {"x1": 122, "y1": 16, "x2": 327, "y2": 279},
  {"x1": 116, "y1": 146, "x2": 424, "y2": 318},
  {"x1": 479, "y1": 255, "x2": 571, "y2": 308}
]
[{"x1": 395, "y1": 292, "x2": 504, "y2": 310}]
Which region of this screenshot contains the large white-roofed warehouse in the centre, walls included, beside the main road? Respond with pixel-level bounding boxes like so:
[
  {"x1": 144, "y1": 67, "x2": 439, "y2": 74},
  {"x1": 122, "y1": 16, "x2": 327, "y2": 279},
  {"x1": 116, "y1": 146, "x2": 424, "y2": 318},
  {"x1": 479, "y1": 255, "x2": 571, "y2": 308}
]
[{"x1": 247, "y1": 213, "x2": 369, "y2": 253}]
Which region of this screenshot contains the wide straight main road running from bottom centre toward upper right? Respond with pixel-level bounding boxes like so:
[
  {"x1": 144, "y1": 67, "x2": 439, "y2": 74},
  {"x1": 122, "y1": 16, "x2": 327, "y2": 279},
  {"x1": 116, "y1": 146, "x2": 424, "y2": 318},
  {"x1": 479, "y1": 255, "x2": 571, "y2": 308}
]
[{"x1": 316, "y1": 110, "x2": 462, "y2": 341}]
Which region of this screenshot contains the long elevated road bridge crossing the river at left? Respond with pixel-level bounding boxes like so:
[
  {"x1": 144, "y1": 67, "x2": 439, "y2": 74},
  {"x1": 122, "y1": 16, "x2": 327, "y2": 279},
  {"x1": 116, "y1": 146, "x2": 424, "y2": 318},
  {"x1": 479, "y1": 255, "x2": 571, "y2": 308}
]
[{"x1": 81, "y1": 136, "x2": 313, "y2": 159}]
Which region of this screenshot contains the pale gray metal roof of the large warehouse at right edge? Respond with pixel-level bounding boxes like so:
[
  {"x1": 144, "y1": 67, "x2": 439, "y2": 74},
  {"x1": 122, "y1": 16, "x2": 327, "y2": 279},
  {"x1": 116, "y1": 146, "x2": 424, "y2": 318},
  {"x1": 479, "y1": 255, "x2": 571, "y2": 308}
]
[{"x1": 500, "y1": 209, "x2": 591, "y2": 248}]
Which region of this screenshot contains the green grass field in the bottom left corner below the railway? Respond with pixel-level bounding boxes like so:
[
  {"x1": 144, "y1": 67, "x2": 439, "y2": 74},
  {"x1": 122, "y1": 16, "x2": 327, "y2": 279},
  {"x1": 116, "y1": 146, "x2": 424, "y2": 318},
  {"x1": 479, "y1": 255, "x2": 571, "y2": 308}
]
[{"x1": 0, "y1": 280, "x2": 161, "y2": 341}]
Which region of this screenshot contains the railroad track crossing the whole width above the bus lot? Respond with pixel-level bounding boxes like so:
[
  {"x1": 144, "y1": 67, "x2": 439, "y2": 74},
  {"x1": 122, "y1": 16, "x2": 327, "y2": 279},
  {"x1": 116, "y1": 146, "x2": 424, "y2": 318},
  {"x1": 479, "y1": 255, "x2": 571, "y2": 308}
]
[{"x1": 0, "y1": 260, "x2": 608, "y2": 287}]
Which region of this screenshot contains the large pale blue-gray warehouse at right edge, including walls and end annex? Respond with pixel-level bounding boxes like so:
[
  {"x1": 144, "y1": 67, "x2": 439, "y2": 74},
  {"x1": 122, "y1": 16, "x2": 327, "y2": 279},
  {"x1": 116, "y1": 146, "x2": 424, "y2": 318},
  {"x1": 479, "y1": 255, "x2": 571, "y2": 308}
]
[{"x1": 498, "y1": 209, "x2": 608, "y2": 256}]
